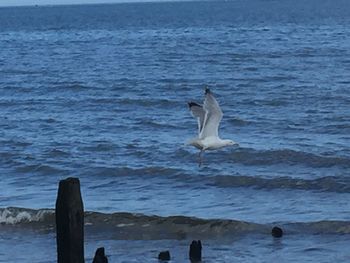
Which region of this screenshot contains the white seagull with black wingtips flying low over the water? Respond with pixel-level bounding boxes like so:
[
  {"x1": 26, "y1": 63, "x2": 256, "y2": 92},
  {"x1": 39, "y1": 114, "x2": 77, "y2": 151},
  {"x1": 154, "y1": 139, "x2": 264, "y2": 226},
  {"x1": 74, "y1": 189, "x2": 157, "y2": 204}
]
[{"x1": 188, "y1": 88, "x2": 238, "y2": 167}]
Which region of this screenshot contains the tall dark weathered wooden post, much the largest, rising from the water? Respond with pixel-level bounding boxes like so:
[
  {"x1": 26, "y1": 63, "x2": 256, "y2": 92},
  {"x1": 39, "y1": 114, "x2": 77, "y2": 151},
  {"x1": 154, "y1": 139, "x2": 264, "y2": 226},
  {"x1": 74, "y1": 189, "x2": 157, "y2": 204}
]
[{"x1": 56, "y1": 178, "x2": 84, "y2": 263}]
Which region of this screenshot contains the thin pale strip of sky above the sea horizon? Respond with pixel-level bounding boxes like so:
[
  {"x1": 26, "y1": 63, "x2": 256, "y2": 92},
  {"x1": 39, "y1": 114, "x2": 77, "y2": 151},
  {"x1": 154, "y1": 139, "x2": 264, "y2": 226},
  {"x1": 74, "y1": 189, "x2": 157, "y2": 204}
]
[{"x1": 0, "y1": 0, "x2": 136, "y2": 6}]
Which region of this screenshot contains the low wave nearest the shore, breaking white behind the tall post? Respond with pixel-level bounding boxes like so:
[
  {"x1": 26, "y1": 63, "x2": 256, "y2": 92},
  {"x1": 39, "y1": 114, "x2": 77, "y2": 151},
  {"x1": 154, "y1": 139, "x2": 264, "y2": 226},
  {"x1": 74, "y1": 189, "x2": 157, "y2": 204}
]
[{"x1": 0, "y1": 207, "x2": 350, "y2": 240}]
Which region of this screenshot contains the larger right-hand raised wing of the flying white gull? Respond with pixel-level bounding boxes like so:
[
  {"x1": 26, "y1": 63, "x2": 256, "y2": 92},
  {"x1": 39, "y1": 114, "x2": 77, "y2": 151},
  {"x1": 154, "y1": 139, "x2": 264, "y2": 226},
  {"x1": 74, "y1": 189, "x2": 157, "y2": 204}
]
[{"x1": 199, "y1": 88, "x2": 223, "y2": 139}]
